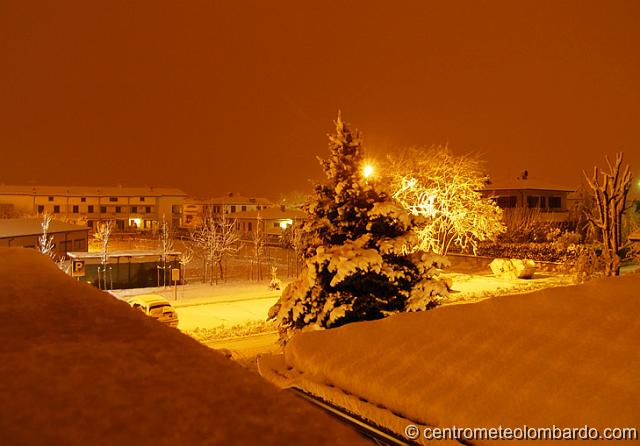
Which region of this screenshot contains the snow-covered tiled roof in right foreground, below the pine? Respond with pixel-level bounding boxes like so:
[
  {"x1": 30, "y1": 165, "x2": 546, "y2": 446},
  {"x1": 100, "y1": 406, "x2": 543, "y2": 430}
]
[{"x1": 259, "y1": 274, "x2": 640, "y2": 444}]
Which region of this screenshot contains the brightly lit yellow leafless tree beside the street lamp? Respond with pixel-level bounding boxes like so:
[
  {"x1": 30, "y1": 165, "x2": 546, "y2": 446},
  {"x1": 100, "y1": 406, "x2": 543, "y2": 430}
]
[{"x1": 389, "y1": 146, "x2": 504, "y2": 255}]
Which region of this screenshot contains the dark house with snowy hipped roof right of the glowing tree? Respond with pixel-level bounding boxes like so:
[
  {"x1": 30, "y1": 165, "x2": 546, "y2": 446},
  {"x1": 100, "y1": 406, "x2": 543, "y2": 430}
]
[{"x1": 481, "y1": 176, "x2": 576, "y2": 222}]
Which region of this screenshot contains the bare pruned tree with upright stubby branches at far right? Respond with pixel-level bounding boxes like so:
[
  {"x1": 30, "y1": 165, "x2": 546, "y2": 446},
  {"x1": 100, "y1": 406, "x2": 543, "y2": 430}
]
[{"x1": 584, "y1": 153, "x2": 631, "y2": 276}]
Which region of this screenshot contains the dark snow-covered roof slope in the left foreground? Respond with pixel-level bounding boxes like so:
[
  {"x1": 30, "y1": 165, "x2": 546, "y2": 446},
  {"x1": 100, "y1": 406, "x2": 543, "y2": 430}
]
[{"x1": 0, "y1": 248, "x2": 364, "y2": 446}]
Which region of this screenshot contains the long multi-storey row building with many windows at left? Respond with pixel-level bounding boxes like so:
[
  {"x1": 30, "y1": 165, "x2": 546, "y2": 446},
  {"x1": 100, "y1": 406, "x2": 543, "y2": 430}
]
[{"x1": 0, "y1": 185, "x2": 187, "y2": 231}]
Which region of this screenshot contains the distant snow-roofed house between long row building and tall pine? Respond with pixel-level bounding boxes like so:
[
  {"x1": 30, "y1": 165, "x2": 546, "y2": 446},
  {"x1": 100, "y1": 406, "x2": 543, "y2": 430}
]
[{"x1": 181, "y1": 192, "x2": 273, "y2": 228}]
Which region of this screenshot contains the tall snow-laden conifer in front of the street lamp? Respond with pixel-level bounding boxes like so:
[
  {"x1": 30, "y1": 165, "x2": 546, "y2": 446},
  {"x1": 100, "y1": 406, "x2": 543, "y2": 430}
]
[{"x1": 269, "y1": 115, "x2": 448, "y2": 342}]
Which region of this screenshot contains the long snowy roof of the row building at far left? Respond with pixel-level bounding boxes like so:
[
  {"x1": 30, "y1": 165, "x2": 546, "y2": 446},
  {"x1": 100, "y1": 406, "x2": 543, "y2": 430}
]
[{"x1": 0, "y1": 184, "x2": 187, "y2": 197}]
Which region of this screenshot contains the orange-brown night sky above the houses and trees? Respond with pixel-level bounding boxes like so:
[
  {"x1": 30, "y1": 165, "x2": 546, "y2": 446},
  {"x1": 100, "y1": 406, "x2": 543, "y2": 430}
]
[{"x1": 0, "y1": 0, "x2": 640, "y2": 198}]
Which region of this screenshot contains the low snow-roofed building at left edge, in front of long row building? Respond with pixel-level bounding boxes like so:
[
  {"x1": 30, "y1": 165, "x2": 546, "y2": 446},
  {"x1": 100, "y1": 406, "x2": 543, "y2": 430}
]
[{"x1": 0, "y1": 218, "x2": 89, "y2": 258}]
